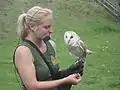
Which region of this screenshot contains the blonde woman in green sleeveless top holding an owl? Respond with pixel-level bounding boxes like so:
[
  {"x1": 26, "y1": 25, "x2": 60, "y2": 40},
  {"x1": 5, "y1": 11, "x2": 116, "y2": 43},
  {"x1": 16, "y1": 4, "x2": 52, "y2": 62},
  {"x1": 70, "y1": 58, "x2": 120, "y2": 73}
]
[{"x1": 14, "y1": 6, "x2": 81, "y2": 90}]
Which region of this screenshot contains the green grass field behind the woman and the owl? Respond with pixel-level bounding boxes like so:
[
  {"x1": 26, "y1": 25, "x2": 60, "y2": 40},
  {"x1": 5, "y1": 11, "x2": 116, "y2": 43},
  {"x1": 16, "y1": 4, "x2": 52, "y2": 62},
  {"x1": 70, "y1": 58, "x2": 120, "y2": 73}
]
[{"x1": 0, "y1": 0, "x2": 120, "y2": 90}]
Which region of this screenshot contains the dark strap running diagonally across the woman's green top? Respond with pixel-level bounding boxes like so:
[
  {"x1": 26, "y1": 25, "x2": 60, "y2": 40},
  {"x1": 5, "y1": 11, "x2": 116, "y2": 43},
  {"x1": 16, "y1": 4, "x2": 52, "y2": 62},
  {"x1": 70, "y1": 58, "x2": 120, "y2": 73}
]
[{"x1": 24, "y1": 40, "x2": 54, "y2": 78}]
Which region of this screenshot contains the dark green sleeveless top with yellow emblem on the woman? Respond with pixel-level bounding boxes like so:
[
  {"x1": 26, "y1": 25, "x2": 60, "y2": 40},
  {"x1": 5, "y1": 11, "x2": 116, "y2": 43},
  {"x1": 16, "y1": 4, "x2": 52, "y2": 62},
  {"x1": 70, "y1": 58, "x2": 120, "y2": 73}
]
[{"x1": 13, "y1": 41, "x2": 59, "y2": 90}]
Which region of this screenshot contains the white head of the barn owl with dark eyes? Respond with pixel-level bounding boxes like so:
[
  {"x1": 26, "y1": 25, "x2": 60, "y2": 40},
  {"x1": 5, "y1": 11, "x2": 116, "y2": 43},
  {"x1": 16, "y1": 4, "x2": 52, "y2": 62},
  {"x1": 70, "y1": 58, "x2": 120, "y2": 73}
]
[{"x1": 64, "y1": 31, "x2": 80, "y2": 46}]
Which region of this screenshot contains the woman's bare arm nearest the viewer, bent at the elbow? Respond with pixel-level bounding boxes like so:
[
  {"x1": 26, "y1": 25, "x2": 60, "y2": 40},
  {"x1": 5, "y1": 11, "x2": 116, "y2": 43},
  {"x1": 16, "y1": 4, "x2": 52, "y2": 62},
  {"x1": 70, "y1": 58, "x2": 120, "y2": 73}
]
[{"x1": 15, "y1": 46, "x2": 80, "y2": 90}]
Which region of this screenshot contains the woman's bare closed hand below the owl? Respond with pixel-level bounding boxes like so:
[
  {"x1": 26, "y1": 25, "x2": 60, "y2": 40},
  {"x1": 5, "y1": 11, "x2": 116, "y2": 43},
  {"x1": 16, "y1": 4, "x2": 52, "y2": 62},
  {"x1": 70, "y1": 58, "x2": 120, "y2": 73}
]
[{"x1": 64, "y1": 73, "x2": 81, "y2": 85}]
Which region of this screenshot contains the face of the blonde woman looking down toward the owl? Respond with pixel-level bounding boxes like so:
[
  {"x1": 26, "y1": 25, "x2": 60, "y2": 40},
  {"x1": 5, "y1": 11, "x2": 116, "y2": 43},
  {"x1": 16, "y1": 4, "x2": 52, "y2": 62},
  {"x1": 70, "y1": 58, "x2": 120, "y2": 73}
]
[{"x1": 35, "y1": 18, "x2": 53, "y2": 39}]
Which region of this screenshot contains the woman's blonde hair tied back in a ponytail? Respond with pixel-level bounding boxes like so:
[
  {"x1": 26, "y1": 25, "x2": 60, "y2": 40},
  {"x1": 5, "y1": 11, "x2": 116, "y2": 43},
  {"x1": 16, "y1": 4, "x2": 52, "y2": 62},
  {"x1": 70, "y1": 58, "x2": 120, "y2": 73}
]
[{"x1": 18, "y1": 6, "x2": 52, "y2": 40}]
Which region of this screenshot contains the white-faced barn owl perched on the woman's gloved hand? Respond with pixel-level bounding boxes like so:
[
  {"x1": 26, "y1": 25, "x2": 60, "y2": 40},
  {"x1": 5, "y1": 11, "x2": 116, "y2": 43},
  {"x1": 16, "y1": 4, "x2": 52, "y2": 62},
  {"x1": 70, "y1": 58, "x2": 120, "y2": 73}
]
[{"x1": 64, "y1": 31, "x2": 93, "y2": 58}]
